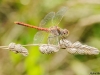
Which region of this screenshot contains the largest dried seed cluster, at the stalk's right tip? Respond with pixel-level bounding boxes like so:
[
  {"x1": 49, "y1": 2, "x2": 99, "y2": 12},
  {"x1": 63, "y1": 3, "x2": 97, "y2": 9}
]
[{"x1": 59, "y1": 39, "x2": 100, "y2": 55}]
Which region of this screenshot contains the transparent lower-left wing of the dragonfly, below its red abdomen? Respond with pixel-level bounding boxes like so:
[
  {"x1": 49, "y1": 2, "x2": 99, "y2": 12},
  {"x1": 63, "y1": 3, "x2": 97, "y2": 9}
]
[{"x1": 33, "y1": 31, "x2": 48, "y2": 44}]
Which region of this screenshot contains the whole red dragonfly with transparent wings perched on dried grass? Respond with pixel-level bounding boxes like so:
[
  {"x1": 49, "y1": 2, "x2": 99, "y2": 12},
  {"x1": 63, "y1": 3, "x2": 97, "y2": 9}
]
[{"x1": 14, "y1": 7, "x2": 69, "y2": 44}]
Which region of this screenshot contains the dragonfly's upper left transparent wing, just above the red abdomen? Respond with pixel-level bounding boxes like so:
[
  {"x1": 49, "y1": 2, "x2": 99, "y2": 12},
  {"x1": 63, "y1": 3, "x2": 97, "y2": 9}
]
[{"x1": 39, "y1": 12, "x2": 55, "y2": 27}]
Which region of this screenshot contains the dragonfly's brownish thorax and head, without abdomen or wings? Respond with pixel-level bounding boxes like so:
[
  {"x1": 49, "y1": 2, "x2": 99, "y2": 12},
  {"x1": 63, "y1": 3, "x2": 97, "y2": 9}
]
[{"x1": 49, "y1": 26, "x2": 69, "y2": 37}]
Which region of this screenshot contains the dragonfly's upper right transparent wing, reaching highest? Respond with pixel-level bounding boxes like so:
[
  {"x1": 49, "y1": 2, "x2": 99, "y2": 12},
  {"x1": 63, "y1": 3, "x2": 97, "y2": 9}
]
[{"x1": 53, "y1": 7, "x2": 67, "y2": 25}]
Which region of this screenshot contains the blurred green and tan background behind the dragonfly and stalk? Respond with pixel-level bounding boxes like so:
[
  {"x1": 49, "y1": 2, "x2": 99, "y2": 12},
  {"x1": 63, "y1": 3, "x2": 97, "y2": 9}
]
[{"x1": 0, "y1": 0, "x2": 100, "y2": 75}]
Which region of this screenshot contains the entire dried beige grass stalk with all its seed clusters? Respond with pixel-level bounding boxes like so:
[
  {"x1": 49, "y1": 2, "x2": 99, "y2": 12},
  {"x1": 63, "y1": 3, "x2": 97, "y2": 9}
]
[{"x1": 0, "y1": 39, "x2": 100, "y2": 56}]
